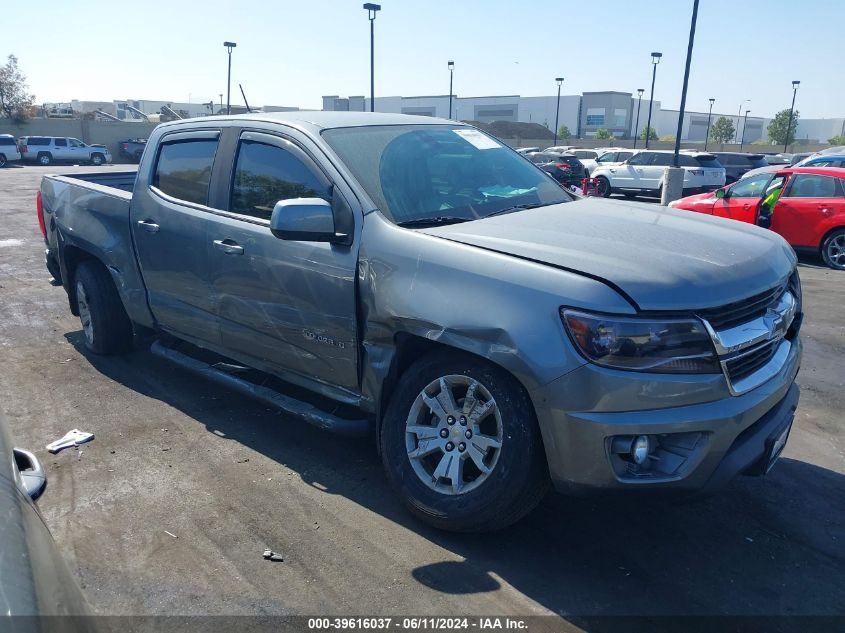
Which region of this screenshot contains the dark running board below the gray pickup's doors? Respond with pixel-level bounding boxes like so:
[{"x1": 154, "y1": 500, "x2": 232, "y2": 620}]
[{"x1": 150, "y1": 341, "x2": 372, "y2": 437}]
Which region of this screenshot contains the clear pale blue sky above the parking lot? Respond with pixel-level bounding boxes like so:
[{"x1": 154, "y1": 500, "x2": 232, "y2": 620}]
[{"x1": 0, "y1": 0, "x2": 845, "y2": 117}]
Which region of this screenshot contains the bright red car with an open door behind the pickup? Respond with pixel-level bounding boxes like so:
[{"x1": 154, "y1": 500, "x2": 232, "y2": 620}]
[{"x1": 669, "y1": 167, "x2": 845, "y2": 270}]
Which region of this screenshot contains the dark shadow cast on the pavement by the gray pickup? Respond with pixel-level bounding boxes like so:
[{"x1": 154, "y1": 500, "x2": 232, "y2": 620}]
[{"x1": 66, "y1": 332, "x2": 845, "y2": 631}]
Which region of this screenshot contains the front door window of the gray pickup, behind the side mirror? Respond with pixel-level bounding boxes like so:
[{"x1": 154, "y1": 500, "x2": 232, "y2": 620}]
[{"x1": 229, "y1": 141, "x2": 331, "y2": 220}]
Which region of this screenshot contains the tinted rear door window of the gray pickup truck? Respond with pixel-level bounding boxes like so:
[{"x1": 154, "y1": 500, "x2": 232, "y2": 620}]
[{"x1": 153, "y1": 139, "x2": 217, "y2": 204}]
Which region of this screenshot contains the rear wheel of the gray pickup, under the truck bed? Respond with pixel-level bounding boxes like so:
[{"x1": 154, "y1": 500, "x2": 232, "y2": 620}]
[{"x1": 74, "y1": 261, "x2": 132, "y2": 355}]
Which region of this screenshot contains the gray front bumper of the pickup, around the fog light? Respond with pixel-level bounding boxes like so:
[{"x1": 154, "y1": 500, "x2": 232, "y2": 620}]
[{"x1": 531, "y1": 337, "x2": 802, "y2": 492}]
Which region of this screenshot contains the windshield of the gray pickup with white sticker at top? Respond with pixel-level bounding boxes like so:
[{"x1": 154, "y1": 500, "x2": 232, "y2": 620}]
[{"x1": 323, "y1": 125, "x2": 573, "y2": 224}]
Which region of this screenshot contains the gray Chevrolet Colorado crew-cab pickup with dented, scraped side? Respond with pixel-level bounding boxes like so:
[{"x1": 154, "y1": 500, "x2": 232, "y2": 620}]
[{"x1": 38, "y1": 112, "x2": 802, "y2": 531}]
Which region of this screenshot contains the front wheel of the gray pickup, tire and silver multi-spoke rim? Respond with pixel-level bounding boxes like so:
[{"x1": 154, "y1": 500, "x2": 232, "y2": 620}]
[{"x1": 379, "y1": 352, "x2": 549, "y2": 532}]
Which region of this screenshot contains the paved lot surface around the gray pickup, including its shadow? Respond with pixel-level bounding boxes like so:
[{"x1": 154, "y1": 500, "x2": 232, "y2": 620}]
[{"x1": 0, "y1": 167, "x2": 845, "y2": 630}]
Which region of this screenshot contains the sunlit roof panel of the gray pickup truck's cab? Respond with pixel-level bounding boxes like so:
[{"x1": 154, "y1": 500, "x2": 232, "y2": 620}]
[{"x1": 157, "y1": 110, "x2": 454, "y2": 130}]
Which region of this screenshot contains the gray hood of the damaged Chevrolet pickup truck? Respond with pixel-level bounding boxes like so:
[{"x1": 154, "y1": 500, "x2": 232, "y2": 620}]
[{"x1": 423, "y1": 198, "x2": 796, "y2": 310}]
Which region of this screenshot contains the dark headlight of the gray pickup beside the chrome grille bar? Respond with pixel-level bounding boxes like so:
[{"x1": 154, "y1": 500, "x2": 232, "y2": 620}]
[{"x1": 560, "y1": 308, "x2": 720, "y2": 374}]
